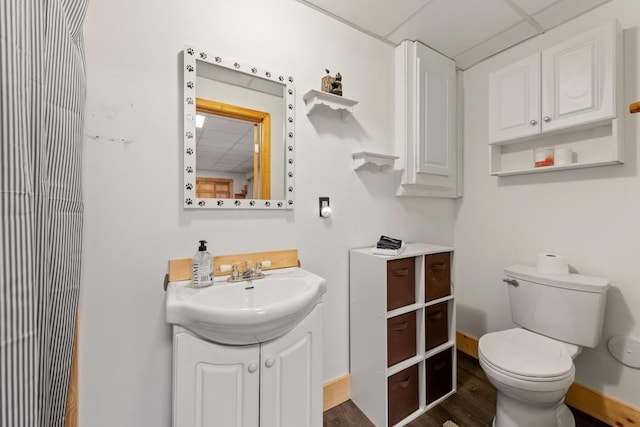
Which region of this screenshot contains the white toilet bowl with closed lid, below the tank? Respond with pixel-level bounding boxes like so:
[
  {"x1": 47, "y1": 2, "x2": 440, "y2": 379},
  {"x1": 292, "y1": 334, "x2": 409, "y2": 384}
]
[{"x1": 478, "y1": 328, "x2": 580, "y2": 427}]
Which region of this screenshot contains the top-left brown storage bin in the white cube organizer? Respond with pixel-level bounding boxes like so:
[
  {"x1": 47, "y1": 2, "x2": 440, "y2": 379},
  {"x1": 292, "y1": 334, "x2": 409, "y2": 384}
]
[{"x1": 387, "y1": 258, "x2": 416, "y2": 311}]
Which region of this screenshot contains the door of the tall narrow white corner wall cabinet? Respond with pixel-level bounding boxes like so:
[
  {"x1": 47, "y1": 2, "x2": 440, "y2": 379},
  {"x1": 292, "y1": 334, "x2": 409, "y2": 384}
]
[{"x1": 415, "y1": 43, "x2": 456, "y2": 177}]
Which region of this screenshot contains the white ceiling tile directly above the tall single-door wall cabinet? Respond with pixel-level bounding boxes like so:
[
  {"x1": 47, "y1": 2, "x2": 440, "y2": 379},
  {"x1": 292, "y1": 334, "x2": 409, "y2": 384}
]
[{"x1": 388, "y1": 0, "x2": 522, "y2": 58}]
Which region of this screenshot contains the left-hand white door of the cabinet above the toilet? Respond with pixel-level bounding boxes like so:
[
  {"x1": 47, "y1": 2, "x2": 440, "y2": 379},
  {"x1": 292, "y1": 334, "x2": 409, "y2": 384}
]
[{"x1": 489, "y1": 53, "x2": 541, "y2": 142}]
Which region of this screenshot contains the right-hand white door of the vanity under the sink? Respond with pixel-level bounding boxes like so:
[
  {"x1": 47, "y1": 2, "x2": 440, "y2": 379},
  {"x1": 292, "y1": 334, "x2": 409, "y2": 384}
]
[{"x1": 260, "y1": 304, "x2": 322, "y2": 427}]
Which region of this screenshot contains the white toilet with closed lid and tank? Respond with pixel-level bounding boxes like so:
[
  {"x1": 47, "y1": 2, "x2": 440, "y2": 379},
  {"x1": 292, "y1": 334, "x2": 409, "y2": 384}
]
[{"x1": 478, "y1": 265, "x2": 610, "y2": 427}]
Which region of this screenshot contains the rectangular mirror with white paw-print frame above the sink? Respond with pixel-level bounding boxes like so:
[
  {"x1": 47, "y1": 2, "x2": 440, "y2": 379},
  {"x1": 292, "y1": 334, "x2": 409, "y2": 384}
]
[{"x1": 183, "y1": 46, "x2": 295, "y2": 209}]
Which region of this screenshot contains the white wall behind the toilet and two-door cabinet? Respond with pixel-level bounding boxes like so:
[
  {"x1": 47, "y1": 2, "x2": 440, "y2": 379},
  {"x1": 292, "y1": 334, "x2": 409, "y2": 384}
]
[{"x1": 454, "y1": 0, "x2": 640, "y2": 406}]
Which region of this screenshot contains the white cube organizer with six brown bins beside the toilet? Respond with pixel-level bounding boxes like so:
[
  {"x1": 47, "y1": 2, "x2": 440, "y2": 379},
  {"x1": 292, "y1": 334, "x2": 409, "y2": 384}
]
[{"x1": 349, "y1": 243, "x2": 456, "y2": 426}]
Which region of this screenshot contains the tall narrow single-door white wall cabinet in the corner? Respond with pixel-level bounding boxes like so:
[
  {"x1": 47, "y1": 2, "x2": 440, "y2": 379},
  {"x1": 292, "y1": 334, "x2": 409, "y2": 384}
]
[{"x1": 395, "y1": 40, "x2": 462, "y2": 197}]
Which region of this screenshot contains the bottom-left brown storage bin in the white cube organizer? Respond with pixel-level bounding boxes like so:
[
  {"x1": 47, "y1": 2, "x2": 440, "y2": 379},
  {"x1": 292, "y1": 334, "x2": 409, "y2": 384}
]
[{"x1": 387, "y1": 365, "x2": 419, "y2": 426}]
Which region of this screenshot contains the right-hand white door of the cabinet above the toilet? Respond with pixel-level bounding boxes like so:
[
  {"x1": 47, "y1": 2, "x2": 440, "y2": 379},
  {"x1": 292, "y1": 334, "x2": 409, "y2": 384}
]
[{"x1": 542, "y1": 23, "x2": 616, "y2": 131}]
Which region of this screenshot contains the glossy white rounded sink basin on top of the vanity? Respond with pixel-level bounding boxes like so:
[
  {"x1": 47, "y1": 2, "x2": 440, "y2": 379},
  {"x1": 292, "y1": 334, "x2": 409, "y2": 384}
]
[{"x1": 166, "y1": 267, "x2": 327, "y2": 345}]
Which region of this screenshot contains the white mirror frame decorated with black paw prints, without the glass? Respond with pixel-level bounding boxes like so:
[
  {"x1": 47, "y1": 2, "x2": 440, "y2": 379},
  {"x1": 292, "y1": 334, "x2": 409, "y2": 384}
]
[{"x1": 183, "y1": 45, "x2": 295, "y2": 210}]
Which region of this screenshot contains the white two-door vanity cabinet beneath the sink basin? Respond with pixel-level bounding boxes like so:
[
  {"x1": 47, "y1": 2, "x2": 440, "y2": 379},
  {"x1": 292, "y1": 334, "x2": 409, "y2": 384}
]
[{"x1": 173, "y1": 304, "x2": 322, "y2": 427}]
